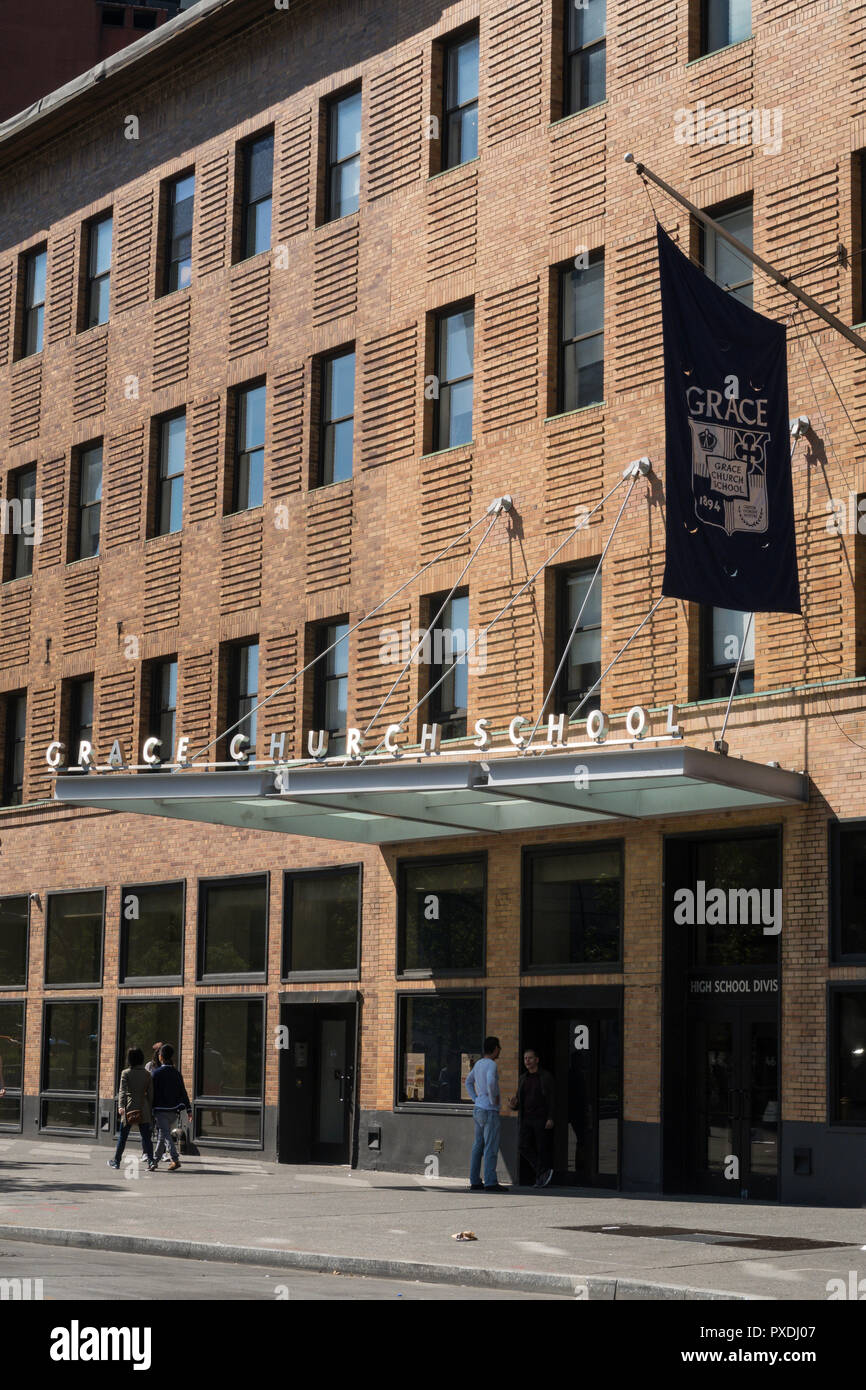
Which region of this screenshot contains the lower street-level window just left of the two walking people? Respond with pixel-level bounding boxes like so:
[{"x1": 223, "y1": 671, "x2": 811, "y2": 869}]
[{"x1": 40, "y1": 999, "x2": 99, "y2": 1133}]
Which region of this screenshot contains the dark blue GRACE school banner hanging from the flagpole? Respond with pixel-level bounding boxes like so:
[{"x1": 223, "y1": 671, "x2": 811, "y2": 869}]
[{"x1": 657, "y1": 227, "x2": 801, "y2": 613}]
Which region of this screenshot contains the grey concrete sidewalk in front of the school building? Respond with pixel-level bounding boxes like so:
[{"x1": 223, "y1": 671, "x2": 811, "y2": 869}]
[{"x1": 0, "y1": 1138, "x2": 866, "y2": 1300}]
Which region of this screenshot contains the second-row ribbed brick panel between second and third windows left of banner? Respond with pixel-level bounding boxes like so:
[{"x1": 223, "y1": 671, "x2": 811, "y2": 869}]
[{"x1": 360, "y1": 324, "x2": 421, "y2": 468}]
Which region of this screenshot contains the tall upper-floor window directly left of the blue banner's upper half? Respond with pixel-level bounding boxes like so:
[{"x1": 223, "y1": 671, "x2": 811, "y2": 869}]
[{"x1": 557, "y1": 252, "x2": 605, "y2": 414}]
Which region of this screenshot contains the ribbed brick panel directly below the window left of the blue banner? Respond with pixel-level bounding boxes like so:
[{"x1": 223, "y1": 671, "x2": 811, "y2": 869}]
[{"x1": 545, "y1": 413, "x2": 605, "y2": 534}]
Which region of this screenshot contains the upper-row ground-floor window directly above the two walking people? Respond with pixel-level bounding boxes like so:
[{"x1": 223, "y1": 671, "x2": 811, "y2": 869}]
[{"x1": 120, "y1": 883, "x2": 183, "y2": 984}]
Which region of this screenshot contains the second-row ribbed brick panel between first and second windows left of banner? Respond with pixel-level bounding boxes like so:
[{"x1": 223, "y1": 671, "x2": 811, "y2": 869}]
[{"x1": 481, "y1": 277, "x2": 539, "y2": 432}]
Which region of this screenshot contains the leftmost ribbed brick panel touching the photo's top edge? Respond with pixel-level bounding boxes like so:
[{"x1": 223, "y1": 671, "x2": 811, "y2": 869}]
[{"x1": 485, "y1": 0, "x2": 544, "y2": 145}]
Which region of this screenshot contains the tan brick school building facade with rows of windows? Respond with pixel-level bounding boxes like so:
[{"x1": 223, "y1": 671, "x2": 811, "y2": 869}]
[{"x1": 0, "y1": 0, "x2": 866, "y2": 1204}]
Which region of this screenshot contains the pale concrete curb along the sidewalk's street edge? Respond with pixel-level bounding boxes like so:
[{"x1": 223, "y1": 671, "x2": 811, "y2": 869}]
[{"x1": 0, "y1": 1226, "x2": 765, "y2": 1302}]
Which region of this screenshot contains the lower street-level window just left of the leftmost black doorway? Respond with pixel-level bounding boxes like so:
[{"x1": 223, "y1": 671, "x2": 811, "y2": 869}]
[{"x1": 195, "y1": 999, "x2": 264, "y2": 1144}]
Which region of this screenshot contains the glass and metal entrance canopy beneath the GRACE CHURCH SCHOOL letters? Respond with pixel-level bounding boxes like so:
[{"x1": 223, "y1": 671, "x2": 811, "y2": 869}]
[{"x1": 56, "y1": 745, "x2": 809, "y2": 845}]
